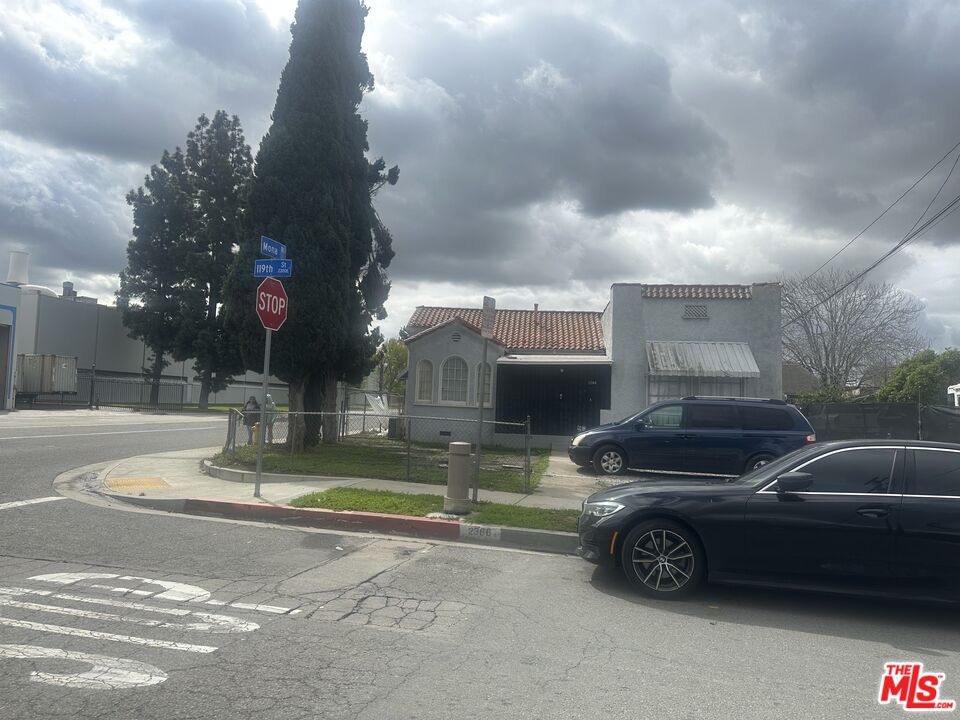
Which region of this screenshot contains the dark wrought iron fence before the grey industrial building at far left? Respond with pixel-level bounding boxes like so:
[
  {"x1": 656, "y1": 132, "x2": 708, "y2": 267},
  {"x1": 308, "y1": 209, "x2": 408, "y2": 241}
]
[{"x1": 17, "y1": 371, "x2": 187, "y2": 411}]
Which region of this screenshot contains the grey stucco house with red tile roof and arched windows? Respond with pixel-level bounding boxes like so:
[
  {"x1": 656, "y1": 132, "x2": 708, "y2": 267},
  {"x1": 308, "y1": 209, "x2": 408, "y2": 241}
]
[{"x1": 405, "y1": 283, "x2": 782, "y2": 444}]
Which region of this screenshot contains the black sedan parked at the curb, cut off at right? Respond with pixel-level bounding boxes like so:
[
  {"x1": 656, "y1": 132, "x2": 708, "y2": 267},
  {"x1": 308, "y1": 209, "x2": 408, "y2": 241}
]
[{"x1": 579, "y1": 440, "x2": 960, "y2": 599}]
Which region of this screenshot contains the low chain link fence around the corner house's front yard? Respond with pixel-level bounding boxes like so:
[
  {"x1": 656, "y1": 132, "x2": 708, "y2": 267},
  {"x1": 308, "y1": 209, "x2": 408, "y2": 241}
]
[{"x1": 224, "y1": 410, "x2": 541, "y2": 492}]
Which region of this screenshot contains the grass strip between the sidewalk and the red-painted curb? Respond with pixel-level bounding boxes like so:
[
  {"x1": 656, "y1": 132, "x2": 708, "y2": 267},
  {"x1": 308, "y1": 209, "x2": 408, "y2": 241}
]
[{"x1": 290, "y1": 488, "x2": 580, "y2": 532}]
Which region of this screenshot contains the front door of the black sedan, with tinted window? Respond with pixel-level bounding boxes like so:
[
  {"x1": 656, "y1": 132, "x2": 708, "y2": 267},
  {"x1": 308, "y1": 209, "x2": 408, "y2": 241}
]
[{"x1": 744, "y1": 446, "x2": 905, "y2": 581}]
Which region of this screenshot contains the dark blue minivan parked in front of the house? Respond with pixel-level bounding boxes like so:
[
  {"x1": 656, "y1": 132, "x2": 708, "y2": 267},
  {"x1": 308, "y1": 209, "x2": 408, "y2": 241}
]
[{"x1": 568, "y1": 397, "x2": 817, "y2": 475}]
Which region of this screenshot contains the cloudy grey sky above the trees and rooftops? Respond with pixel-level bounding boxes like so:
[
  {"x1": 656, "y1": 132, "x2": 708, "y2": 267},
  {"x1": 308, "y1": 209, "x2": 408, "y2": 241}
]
[{"x1": 0, "y1": 0, "x2": 960, "y2": 347}]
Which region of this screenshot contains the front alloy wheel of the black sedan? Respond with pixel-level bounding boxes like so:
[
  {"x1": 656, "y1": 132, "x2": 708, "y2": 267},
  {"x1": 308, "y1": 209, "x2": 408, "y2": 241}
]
[{"x1": 621, "y1": 520, "x2": 705, "y2": 597}]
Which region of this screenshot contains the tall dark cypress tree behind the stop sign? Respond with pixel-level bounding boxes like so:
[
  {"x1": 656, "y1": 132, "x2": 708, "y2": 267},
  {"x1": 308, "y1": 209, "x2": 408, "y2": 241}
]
[{"x1": 227, "y1": 0, "x2": 389, "y2": 449}]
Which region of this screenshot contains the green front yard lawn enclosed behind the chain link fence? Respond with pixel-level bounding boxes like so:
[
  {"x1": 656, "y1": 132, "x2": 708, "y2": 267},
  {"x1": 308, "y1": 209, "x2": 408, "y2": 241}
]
[{"x1": 213, "y1": 436, "x2": 550, "y2": 492}]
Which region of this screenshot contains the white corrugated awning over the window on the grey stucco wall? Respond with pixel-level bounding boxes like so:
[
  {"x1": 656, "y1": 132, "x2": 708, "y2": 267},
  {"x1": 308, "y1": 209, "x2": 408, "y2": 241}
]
[{"x1": 647, "y1": 341, "x2": 760, "y2": 378}]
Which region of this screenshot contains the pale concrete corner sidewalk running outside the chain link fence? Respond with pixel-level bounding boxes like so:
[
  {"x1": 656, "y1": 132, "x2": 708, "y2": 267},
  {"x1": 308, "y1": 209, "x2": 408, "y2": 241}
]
[{"x1": 100, "y1": 447, "x2": 596, "y2": 510}]
